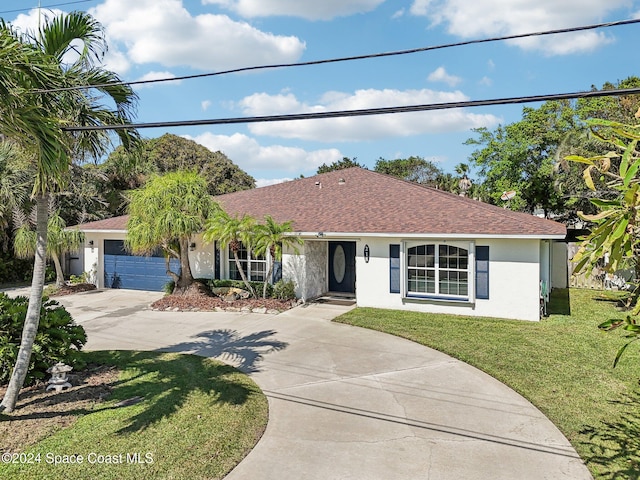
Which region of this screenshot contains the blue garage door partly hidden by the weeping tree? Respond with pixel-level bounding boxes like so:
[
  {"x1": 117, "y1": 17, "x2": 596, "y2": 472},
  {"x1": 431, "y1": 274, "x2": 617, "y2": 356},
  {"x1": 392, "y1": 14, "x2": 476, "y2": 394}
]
[{"x1": 104, "y1": 240, "x2": 180, "y2": 291}]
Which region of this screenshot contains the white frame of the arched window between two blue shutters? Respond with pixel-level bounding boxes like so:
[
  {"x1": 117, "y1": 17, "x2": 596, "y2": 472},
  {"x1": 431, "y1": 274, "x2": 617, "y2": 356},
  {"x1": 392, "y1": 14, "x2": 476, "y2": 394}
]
[{"x1": 400, "y1": 239, "x2": 475, "y2": 303}]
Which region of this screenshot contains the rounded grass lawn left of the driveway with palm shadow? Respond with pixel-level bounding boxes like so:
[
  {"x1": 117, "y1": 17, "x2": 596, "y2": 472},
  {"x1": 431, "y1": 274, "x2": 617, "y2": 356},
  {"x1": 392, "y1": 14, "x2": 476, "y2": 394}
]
[{"x1": 0, "y1": 351, "x2": 268, "y2": 480}]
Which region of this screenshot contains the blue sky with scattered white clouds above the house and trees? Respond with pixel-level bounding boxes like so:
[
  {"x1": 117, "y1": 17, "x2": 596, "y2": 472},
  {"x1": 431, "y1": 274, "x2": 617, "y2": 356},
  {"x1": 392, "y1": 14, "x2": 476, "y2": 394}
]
[{"x1": 0, "y1": 0, "x2": 640, "y2": 185}]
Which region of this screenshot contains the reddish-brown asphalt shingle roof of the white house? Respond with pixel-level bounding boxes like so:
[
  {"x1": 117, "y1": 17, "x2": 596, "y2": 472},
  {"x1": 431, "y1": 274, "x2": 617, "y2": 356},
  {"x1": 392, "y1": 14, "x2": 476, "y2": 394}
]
[{"x1": 80, "y1": 167, "x2": 566, "y2": 238}]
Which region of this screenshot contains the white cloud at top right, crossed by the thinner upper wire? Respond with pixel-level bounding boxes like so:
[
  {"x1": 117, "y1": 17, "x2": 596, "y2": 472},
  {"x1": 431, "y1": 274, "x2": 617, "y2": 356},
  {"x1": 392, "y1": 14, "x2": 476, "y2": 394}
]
[{"x1": 410, "y1": 0, "x2": 629, "y2": 55}]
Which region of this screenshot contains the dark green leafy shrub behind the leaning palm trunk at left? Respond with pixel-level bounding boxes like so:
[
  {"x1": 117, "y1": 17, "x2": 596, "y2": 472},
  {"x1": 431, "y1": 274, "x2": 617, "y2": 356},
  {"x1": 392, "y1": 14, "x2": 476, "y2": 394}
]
[{"x1": 0, "y1": 293, "x2": 87, "y2": 385}]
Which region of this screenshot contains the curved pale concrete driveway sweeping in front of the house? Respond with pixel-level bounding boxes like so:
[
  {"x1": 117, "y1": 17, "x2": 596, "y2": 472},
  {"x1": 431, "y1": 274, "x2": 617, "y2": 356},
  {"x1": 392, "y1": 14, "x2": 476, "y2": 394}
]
[{"x1": 18, "y1": 290, "x2": 591, "y2": 480}]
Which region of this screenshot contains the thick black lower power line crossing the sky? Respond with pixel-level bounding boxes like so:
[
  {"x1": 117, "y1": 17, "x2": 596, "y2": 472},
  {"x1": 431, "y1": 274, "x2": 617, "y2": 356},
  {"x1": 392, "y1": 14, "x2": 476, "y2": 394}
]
[{"x1": 62, "y1": 88, "x2": 640, "y2": 132}]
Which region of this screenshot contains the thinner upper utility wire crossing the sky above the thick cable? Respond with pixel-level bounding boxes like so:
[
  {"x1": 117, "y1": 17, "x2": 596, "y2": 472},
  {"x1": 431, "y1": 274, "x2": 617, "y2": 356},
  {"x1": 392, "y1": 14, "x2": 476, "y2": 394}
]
[{"x1": 35, "y1": 18, "x2": 640, "y2": 93}]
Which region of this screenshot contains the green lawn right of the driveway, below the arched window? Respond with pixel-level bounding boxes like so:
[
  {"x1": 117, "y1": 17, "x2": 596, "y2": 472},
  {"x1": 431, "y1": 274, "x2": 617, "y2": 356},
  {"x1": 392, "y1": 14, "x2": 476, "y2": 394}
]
[{"x1": 336, "y1": 289, "x2": 640, "y2": 479}]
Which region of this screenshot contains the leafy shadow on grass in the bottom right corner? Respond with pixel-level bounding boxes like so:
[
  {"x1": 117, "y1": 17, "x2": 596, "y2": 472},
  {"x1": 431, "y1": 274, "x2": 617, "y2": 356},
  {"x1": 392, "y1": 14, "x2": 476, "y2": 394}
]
[{"x1": 580, "y1": 390, "x2": 640, "y2": 480}]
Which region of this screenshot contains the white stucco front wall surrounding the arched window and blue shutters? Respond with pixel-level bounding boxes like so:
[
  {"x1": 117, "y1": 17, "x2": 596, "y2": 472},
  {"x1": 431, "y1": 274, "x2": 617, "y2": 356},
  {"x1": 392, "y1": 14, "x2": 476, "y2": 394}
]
[{"x1": 356, "y1": 238, "x2": 540, "y2": 321}]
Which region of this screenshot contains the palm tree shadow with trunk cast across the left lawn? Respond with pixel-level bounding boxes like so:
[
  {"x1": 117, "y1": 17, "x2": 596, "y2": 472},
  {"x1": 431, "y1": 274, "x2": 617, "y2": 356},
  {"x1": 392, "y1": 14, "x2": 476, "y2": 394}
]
[{"x1": 0, "y1": 351, "x2": 261, "y2": 433}]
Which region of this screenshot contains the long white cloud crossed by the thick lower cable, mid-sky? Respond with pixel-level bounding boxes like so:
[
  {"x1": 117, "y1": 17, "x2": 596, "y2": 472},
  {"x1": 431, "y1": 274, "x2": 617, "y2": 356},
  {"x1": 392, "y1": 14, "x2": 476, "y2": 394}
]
[{"x1": 240, "y1": 89, "x2": 500, "y2": 142}]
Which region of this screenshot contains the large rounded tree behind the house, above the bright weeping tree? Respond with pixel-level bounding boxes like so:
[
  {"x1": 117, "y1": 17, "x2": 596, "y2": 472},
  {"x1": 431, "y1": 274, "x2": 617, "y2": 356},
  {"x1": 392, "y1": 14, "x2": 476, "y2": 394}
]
[{"x1": 100, "y1": 133, "x2": 255, "y2": 213}]
